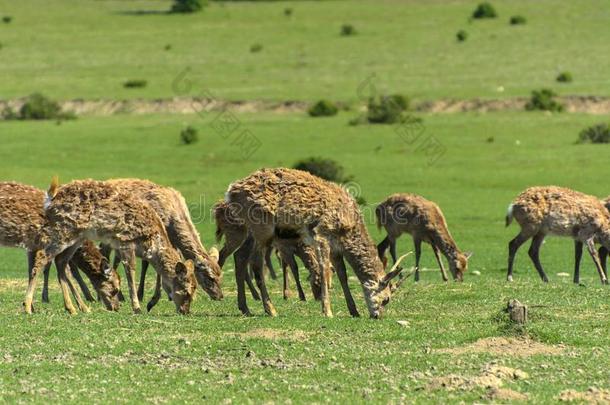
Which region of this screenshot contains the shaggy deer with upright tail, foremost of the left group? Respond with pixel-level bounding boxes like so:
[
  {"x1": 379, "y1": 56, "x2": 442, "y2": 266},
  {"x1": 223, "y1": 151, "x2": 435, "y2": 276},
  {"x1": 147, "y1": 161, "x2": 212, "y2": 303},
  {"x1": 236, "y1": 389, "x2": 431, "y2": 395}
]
[{"x1": 25, "y1": 177, "x2": 197, "y2": 314}]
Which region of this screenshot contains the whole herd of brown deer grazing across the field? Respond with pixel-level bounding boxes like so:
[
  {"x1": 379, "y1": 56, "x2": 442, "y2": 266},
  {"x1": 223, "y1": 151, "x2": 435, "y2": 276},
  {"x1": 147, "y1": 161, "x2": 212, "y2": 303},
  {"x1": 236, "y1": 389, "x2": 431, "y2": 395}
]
[{"x1": 0, "y1": 168, "x2": 610, "y2": 318}]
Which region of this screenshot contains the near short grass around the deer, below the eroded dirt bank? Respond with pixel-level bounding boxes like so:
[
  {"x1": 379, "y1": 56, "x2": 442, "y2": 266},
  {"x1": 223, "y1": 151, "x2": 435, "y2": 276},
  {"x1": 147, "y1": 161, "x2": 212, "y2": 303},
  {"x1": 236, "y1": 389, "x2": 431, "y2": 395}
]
[{"x1": 0, "y1": 110, "x2": 610, "y2": 403}]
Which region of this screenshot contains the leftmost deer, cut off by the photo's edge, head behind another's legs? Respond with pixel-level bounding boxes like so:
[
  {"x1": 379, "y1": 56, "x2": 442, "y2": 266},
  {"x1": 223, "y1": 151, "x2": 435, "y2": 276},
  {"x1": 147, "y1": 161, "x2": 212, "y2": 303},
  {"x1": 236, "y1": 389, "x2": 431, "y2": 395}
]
[{"x1": 0, "y1": 182, "x2": 120, "y2": 313}]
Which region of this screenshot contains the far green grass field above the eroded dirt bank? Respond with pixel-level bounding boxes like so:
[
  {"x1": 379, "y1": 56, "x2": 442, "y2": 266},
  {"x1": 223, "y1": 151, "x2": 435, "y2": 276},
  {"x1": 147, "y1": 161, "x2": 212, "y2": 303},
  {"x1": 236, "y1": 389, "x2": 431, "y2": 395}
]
[{"x1": 0, "y1": 0, "x2": 610, "y2": 101}]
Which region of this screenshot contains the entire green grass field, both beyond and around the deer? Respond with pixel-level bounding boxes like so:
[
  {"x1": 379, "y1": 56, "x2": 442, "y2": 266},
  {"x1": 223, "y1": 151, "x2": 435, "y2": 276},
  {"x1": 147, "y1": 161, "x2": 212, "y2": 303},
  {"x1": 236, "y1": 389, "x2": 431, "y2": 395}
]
[{"x1": 0, "y1": 0, "x2": 610, "y2": 404}]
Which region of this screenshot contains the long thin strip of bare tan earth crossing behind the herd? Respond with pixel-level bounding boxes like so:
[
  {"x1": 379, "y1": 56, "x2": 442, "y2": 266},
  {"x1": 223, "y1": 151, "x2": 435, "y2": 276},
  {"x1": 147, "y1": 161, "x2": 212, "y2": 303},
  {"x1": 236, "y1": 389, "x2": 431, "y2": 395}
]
[{"x1": 0, "y1": 96, "x2": 610, "y2": 116}]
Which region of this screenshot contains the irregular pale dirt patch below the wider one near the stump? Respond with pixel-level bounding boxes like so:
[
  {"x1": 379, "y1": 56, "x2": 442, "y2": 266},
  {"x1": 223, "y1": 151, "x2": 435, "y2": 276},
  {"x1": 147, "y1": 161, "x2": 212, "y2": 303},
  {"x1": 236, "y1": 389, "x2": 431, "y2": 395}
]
[{"x1": 428, "y1": 364, "x2": 528, "y2": 391}]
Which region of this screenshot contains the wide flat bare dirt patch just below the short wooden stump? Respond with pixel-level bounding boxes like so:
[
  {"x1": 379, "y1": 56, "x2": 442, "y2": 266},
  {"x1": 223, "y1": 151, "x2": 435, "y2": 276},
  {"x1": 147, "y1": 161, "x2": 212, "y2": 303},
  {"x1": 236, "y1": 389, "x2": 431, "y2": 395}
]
[{"x1": 435, "y1": 337, "x2": 565, "y2": 357}]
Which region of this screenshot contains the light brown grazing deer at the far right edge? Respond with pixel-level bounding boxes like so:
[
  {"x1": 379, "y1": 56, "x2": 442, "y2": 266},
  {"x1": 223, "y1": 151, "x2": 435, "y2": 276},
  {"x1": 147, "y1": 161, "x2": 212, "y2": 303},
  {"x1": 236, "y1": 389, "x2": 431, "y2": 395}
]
[{"x1": 506, "y1": 186, "x2": 610, "y2": 284}]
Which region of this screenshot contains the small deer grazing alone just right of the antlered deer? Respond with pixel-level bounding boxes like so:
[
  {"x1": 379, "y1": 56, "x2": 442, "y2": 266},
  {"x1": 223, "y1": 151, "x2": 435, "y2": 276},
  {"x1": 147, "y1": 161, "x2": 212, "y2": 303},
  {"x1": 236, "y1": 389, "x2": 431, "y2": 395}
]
[{"x1": 375, "y1": 194, "x2": 472, "y2": 282}]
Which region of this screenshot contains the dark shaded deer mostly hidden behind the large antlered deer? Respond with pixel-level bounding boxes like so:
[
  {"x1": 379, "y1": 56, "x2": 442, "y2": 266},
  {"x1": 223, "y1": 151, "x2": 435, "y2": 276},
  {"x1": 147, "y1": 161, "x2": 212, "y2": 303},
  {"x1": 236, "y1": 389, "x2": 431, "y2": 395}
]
[{"x1": 213, "y1": 201, "x2": 328, "y2": 315}]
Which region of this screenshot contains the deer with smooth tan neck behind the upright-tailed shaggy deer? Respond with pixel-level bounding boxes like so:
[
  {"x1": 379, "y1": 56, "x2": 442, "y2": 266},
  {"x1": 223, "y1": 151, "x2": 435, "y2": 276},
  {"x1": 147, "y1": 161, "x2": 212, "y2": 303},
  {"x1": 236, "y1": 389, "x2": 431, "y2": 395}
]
[{"x1": 97, "y1": 179, "x2": 223, "y2": 310}]
